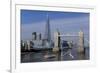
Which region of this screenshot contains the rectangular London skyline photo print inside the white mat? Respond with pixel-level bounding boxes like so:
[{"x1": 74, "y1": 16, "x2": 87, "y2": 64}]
[{"x1": 21, "y1": 10, "x2": 90, "y2": 63}]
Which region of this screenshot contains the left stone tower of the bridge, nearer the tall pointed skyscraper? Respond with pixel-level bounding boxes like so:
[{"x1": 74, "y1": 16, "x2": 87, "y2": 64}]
[{"x1": 53, "y1": 32, "x2": 60, "y2": 52}]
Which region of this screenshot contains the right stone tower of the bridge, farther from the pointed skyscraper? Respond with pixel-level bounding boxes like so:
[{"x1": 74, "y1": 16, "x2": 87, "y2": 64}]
[{"x1": 78, "y1": 31, "x2": 84, "y2": 53}]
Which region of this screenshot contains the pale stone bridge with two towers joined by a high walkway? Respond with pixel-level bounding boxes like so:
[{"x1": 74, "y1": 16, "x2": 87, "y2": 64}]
[{"x1": 53, "y1": 31, "x2": 84, "y2": 53}]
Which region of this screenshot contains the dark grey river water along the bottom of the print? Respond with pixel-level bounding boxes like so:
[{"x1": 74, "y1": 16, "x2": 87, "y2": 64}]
[{"x1": 21, "y1": 49, "x2": 89, "y2": 63}]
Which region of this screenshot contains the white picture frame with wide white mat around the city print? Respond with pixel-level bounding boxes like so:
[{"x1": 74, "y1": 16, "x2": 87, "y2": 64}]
[{"x1": 11, "y1": 0, "x2": 96, "y2": 73}]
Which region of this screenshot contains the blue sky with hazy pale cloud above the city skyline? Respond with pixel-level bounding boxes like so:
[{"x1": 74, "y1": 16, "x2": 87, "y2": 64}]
[{"x1": 21, "y1": 10, "x2": 89, "y2": 40}]
